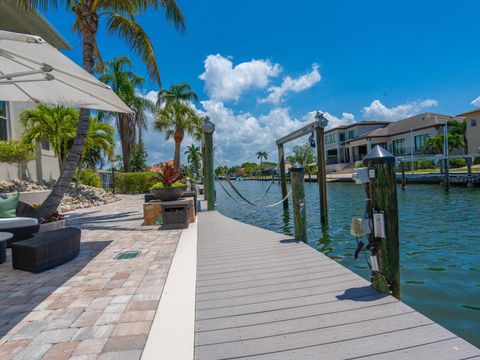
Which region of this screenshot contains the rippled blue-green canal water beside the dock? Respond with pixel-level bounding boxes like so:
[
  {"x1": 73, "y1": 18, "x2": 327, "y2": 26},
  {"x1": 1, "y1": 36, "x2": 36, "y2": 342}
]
[{"x1": 216, "y1": 181, "x2": 480, "y2": 347}]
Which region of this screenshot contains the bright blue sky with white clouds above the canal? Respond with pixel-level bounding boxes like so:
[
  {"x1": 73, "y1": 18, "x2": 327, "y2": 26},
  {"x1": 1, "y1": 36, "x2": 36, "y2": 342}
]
[{"x1": 45, "y1": 0, "x2": 480, "y2": 164}]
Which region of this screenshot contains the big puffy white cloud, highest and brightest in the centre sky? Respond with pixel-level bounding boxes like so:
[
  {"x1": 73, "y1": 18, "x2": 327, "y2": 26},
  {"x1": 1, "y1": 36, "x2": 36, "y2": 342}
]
[{"x1": 200, "y1": 54, "x2": 281, "y2": 101}]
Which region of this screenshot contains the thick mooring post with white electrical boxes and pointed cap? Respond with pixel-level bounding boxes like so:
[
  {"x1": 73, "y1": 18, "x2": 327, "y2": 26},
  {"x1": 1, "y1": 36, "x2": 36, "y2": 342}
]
[{"x1": 363, "y1": 145, "x2": 400, "y2": 299}]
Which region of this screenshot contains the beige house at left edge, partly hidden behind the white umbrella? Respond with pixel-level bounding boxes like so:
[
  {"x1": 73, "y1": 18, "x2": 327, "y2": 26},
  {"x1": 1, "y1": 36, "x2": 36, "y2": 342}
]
[{"x1": 0, "y1": 0, "x2": 71, "y2": 180}]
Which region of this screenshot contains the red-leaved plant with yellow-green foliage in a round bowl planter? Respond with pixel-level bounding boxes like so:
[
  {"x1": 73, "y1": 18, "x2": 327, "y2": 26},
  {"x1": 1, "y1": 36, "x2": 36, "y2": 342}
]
[{"x1": 150, "y1": 163, "x2": 187, "y2": 201}]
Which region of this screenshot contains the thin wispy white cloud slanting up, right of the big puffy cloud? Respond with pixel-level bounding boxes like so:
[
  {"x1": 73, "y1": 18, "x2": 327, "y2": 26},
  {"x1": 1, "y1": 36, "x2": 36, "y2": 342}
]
[{"x1": 259, "y1": 64, "x2": 322, "y2": 104}]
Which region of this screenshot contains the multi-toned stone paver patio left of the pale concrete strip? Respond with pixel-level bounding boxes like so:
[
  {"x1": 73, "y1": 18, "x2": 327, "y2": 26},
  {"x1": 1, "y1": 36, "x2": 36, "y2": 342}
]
[{"x1": 0, "y1": 196, "x2": 181, "y2": 360}]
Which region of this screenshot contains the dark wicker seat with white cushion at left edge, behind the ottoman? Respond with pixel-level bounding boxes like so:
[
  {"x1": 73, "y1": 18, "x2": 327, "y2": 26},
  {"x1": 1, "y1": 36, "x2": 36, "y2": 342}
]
[{"x1": 0, "y1": 201, "x2": 39, "y2": 247}]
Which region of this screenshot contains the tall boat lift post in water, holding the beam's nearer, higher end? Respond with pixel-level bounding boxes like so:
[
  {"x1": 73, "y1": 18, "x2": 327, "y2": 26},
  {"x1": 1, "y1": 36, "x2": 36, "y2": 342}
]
[{"x1": 315, "y1": 111, "x2": 328, "y2": 225}]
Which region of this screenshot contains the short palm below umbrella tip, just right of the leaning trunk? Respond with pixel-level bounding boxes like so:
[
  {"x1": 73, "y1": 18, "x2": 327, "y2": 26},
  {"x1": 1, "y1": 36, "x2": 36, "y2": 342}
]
[{"x1": 77, "y1": 116, "x2": 115, "y2": 187}]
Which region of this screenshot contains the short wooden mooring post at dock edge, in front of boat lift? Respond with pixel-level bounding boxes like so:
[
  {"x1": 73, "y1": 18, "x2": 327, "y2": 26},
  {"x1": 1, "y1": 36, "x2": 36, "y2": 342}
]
[{"x1": 290, "y1": 164, "x2": 307, "y2": 242}]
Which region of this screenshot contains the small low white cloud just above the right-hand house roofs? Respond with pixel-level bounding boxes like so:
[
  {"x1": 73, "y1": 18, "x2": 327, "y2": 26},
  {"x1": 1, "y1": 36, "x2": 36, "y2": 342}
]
[{"x1": 362, "y1": 99, "x2": 438, "y2": 120}]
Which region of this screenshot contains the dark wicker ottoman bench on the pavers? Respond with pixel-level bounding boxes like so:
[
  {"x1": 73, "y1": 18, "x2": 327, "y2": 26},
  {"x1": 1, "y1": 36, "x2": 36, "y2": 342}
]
[{"x1": 11, "y1": 227, "x2": 81, "y2": 273}]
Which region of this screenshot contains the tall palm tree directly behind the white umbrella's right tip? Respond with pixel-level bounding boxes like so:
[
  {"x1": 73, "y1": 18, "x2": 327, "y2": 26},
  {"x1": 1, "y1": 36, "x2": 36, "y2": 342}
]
[{"x1": 97, "y1": 56, "x2": 155, "y2": 171}]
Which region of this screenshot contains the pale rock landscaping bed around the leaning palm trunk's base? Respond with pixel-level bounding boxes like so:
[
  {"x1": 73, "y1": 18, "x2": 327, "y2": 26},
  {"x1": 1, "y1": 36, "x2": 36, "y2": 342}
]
[{"x1": 0, "y1": 180, "x2": 120, "y2": 212}]
